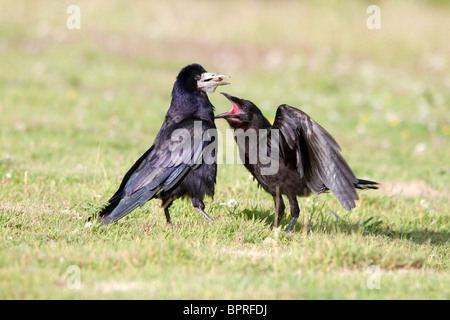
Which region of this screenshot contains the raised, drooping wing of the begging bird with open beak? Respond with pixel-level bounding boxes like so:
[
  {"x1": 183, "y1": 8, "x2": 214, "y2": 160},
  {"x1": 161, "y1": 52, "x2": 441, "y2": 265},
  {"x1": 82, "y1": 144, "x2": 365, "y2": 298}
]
[{"x1": 273, "y1": 104, "x2": 358, "y2": 210}]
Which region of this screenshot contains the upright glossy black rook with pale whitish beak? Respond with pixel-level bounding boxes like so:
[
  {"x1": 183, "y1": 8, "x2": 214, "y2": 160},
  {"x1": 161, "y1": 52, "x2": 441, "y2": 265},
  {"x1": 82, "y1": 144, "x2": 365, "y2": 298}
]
[{"x1": 99, "y1": 64, "x2": 228, "y2": 225}]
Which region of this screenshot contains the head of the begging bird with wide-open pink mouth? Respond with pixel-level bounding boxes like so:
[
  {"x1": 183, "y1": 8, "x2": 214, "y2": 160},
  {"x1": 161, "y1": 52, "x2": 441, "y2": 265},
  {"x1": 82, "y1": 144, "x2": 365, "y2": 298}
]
[{"x1": 215, "y1": 92, "x2": 264, "y2": 129}]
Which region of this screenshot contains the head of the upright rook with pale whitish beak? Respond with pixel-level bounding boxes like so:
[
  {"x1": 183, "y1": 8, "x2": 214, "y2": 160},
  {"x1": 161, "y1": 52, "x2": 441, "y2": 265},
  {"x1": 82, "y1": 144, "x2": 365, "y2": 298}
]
[{"x1": 176, "y1": 63, "x2": 230, "y2": 93}]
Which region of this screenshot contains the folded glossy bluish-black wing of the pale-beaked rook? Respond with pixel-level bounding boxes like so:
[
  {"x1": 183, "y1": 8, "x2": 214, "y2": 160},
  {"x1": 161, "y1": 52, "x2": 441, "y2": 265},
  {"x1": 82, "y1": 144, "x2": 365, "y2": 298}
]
[{"x1": 100, "y1": 120, "x2": 214, "y2": 224}]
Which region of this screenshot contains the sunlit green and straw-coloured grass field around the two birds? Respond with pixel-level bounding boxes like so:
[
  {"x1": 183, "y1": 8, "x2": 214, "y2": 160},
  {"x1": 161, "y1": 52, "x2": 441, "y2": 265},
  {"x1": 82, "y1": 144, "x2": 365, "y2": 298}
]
[{"x1": 0, "y1": 0, "x2": 450, "y2": 299}]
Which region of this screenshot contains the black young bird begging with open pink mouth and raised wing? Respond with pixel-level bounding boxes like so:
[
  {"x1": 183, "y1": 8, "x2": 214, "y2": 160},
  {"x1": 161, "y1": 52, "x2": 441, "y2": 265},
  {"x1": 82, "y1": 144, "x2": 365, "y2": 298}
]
[{"x1": 216, "y1": 93, "x2": 378, "y2": 231}]
